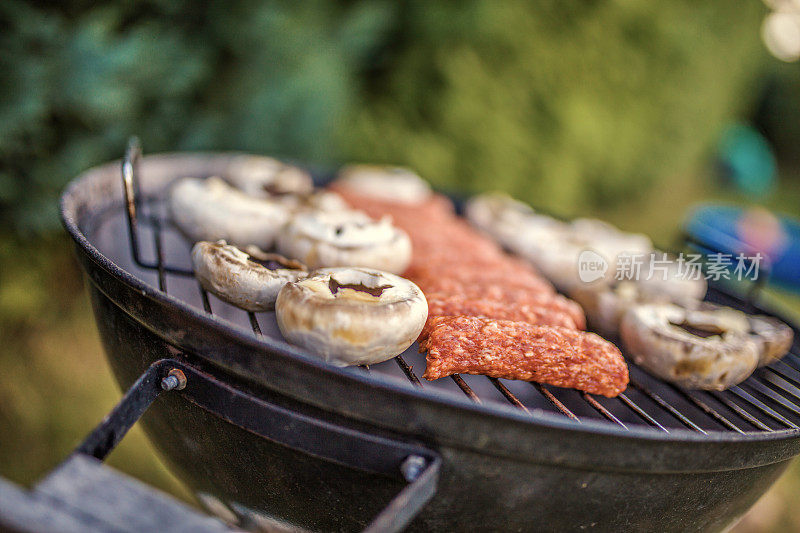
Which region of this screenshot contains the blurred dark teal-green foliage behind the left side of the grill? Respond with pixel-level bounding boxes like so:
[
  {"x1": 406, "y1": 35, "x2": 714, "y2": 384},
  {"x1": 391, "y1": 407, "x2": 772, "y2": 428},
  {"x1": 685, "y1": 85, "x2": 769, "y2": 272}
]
[{"x1": 0, "y1": 0, "x2": 392, "y2": 231}]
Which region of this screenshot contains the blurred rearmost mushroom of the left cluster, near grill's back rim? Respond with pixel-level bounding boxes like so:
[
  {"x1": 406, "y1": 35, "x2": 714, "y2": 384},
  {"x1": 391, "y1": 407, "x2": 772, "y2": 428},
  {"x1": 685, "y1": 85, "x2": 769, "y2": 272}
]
[{"x1": 224, "y1": 155, "x2": 314, "y2": 198}]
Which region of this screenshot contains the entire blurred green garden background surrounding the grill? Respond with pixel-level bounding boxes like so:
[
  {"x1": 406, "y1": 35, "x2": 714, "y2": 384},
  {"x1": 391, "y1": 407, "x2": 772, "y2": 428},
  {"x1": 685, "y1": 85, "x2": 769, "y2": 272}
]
[{"x1": 0, "y1": 0, "x2": 800, "y2": 532}]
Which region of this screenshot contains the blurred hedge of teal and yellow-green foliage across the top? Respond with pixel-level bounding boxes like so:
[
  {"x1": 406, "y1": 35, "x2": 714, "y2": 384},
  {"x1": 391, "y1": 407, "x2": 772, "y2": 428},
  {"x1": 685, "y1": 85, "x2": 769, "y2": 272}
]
[{"x1": 0, "y1": 0, "x2": 762, "y2": 232}]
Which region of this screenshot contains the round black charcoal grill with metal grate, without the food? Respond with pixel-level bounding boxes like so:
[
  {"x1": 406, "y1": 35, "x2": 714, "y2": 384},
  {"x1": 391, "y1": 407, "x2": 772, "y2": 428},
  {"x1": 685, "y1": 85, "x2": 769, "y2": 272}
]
[{"x1": 61, "y1": 144, "x2": 800, "y2": 531}]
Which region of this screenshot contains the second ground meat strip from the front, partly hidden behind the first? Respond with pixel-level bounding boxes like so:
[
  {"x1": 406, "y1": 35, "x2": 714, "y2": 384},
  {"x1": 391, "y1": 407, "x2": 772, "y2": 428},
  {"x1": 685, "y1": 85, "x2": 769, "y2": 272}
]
[{"x1": 419, "y1": 293, "x2": 579, "y2": 342}]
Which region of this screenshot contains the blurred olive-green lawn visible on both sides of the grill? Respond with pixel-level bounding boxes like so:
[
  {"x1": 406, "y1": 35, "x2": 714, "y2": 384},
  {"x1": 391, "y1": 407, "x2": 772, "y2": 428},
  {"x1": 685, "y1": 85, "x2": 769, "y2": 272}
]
[{"x1": 0, "y1": 162, "x2": 800, "y2": 533}]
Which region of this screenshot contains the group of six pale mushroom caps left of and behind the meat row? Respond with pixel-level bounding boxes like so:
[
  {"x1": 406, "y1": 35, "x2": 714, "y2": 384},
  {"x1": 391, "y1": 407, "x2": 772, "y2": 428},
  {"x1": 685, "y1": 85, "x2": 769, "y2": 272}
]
[{"x1": 169, "y1": 156, "x2": 430, "y2": 366}]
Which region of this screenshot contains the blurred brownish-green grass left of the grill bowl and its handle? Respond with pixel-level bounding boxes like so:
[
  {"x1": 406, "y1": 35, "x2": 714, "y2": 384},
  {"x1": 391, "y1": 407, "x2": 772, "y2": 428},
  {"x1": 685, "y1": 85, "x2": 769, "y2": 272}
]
[{"x1": 0, "y1": 235, "x2": 191, "y2": 501}]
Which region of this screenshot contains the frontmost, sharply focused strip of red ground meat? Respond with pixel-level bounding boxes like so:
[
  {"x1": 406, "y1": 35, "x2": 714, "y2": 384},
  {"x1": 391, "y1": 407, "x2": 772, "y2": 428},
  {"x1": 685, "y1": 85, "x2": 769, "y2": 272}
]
[{"x1": 421, "y1": 316, "x2": 628, "y2": 398}]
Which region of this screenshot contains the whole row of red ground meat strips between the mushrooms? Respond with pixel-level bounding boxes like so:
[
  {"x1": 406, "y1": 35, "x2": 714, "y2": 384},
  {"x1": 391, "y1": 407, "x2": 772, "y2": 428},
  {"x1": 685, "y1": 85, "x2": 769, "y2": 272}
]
[{"x1": 330, "y1": 179, "x2": 628, "y2": 397}]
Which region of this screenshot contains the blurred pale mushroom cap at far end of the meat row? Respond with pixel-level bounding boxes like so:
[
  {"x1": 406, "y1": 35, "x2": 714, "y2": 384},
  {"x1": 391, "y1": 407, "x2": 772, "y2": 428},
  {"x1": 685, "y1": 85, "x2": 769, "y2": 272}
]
[{"x1": 336, "y1": 165, "x2": 431, "y2": 204}]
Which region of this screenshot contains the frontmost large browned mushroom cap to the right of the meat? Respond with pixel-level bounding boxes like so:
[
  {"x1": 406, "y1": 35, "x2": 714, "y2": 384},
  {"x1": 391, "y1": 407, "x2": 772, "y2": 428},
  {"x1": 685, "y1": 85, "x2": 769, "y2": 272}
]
[{"x1": 620, "y1": 304, "x2": 759, "y2": 390}]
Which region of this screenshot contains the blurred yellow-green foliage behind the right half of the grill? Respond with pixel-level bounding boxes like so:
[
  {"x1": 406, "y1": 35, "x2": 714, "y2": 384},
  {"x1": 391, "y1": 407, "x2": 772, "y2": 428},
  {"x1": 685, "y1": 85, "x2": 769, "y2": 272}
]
[{"x1": 350, "y1": 0, "x2": 764, "y2": 215}]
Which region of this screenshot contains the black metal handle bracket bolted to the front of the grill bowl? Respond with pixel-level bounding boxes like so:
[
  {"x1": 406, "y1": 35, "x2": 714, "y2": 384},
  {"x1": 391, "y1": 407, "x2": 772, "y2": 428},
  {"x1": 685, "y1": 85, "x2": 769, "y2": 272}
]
[{"x1": 68, "y1": 359, "x2": 442, "y2": 533}]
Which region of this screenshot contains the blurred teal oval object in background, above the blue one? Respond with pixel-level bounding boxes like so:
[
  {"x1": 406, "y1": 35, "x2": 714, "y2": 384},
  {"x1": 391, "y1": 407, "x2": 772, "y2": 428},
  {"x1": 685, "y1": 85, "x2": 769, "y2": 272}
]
[{"x1": 718, "y1": 124, "x2": 777, "y2": 196}]
